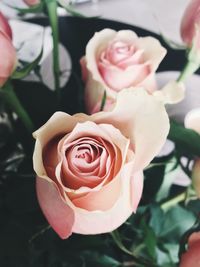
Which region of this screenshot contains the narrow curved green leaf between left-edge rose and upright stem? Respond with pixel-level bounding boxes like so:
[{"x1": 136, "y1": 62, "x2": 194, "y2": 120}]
[{"x1": 11, "y1": 48, "x2": 43, "y2": 79}]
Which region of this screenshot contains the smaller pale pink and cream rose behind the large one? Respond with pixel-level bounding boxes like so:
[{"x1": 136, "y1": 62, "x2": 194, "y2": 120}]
[{"x1": 81, "y1": 29, "x2": 166, "y2": 114}]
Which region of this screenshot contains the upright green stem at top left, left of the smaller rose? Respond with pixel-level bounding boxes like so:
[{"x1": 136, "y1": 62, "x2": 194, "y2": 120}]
[{"x1": 45, "y1": 0, "x2": 60, "y2": 103}]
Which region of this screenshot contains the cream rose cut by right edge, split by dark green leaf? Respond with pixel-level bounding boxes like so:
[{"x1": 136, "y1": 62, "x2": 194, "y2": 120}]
[{"x1": 185, "y1": 108, "x2": 200, "y2": 198}]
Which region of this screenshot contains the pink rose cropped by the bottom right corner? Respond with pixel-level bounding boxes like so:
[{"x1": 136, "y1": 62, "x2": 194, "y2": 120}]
[{"x1": 179, "y1": 232, "x2": 200, "y2": 267}]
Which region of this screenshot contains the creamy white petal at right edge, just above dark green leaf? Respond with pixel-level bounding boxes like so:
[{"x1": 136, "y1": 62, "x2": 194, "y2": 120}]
[{"x1": 184, "y1": 108, "x2": 200, "y2": 134}]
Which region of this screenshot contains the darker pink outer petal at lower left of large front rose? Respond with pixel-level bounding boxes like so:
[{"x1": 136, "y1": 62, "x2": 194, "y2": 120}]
[{"x1": 36, "y1": 178, "x2": 74, "y2": 239}]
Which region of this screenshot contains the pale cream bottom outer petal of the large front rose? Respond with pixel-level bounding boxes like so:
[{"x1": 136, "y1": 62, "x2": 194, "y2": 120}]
[{"x1": 73, "y1": 164, "x2": 142, "y2": 234}]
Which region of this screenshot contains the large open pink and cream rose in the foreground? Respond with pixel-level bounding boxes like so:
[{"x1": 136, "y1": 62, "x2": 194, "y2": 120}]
[{"x1": 33, "y1": 88, "x2": 169, "y2": 238}]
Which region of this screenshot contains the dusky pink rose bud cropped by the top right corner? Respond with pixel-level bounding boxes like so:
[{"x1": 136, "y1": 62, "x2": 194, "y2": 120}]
[{"x1": 181, "y1": 0, "x2": 200, "y2": 47}]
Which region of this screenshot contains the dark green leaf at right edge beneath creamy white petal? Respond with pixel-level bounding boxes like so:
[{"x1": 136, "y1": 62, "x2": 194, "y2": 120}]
[{"x1": 168, "y1": 120, "x2": 200, "y2": 156}]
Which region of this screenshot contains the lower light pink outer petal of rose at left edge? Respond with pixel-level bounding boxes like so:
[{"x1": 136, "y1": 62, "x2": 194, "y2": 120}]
[{"x1": 0, "y1": 30, "x2": 17, "y2": 87}]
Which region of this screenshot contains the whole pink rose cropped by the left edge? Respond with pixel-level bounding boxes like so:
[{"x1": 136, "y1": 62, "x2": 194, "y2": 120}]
[{"x1": 0, "y1": 13, "x2": 17, "y2": 87}]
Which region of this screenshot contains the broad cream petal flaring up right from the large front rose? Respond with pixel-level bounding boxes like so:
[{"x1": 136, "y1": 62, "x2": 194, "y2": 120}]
[{"x1": 91, "y1": 88, "x2": 169, "y2": 170}]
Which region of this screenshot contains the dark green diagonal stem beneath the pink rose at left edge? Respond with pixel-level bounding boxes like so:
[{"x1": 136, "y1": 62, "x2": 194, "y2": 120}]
[{"x1": 0, "y1": 82, "x2": 34, "y2": 133}]
